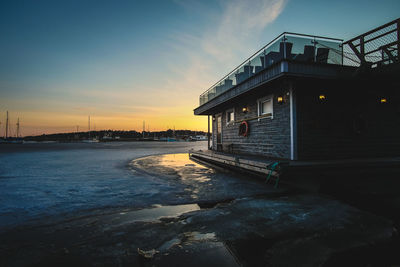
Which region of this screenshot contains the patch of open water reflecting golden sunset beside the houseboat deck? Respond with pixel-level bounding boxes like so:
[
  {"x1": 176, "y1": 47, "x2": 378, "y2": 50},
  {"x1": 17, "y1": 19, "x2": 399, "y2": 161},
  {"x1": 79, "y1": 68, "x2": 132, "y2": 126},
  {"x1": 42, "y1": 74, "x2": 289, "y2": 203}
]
[{"x1": 130, "y1": 153, "x2": 276, "y2": 203}]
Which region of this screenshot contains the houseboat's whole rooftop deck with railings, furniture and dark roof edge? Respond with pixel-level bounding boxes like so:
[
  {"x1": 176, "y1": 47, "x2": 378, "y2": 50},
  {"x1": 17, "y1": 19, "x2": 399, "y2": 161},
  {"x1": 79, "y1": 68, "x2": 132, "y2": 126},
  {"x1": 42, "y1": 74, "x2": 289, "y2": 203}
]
[{"x1": 194, "y1": 19, "x2": 400, "y2": 115}]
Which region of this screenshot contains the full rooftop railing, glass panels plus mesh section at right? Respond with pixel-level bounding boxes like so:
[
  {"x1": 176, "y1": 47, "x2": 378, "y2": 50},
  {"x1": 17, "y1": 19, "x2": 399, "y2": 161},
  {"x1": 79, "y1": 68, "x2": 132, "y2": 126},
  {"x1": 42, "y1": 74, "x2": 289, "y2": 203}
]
[{"x1": 200, "y1": 18, "x2": 400, "y2": 106}]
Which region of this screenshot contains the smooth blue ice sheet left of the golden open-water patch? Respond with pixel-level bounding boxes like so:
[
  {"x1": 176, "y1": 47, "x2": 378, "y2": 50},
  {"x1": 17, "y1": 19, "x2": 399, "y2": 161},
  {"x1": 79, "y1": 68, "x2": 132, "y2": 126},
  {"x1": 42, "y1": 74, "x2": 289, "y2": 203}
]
[{"x1": 0, "y1": 142, "x2": 206, "y2": 228}]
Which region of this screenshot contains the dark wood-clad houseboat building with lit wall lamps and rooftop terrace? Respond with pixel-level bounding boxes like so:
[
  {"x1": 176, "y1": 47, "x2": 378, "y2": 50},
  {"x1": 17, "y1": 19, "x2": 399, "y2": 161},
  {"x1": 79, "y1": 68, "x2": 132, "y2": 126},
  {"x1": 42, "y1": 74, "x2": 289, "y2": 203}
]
[{"x1": 194, "y1": 19, "x2": 400, "y2": 160}]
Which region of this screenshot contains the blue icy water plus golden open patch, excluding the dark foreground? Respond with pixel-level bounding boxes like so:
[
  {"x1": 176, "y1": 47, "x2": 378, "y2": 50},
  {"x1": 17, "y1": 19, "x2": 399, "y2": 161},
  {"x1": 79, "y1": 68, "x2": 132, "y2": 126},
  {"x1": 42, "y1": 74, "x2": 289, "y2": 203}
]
[{"x1": 0, "y1": 142, "x2": 276, "y2": 230}]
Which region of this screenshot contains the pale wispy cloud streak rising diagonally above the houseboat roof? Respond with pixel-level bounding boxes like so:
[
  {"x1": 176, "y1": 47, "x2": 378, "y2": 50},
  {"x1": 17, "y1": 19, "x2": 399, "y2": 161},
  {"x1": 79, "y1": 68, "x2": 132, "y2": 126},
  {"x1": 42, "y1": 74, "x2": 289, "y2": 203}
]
[{"x1": 167, "y1": 0, "x2": 287, "y2": 99}]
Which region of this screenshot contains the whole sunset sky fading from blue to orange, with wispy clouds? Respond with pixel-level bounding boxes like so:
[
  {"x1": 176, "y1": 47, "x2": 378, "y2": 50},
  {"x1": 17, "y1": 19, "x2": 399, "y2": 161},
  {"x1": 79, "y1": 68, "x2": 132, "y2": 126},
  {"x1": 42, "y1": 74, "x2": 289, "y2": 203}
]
[{"x1": 0, "y1": 0, "x2": 400, "y2": 136}]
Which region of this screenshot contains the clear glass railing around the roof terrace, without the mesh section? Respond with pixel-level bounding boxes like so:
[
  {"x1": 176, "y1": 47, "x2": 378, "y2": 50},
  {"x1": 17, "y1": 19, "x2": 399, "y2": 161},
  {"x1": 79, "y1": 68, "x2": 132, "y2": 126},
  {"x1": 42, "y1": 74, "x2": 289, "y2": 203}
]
[{"x1": 200, "y1": 32, "x2": 343, "y2": 105}]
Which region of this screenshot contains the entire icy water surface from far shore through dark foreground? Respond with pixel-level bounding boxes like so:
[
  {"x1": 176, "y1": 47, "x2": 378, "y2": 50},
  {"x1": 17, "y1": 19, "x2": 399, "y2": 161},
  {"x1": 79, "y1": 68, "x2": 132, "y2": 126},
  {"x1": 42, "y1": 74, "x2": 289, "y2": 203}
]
[{"x1": 0, "y1": 142, "x2": 398, "y2": 266}]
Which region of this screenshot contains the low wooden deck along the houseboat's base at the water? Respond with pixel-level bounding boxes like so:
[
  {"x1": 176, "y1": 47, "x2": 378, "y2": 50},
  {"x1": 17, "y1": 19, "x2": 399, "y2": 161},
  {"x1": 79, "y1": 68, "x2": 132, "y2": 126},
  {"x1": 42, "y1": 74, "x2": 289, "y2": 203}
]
[{"x1": 189, "y1": 150, "x2": 400, "y2": 191}]
